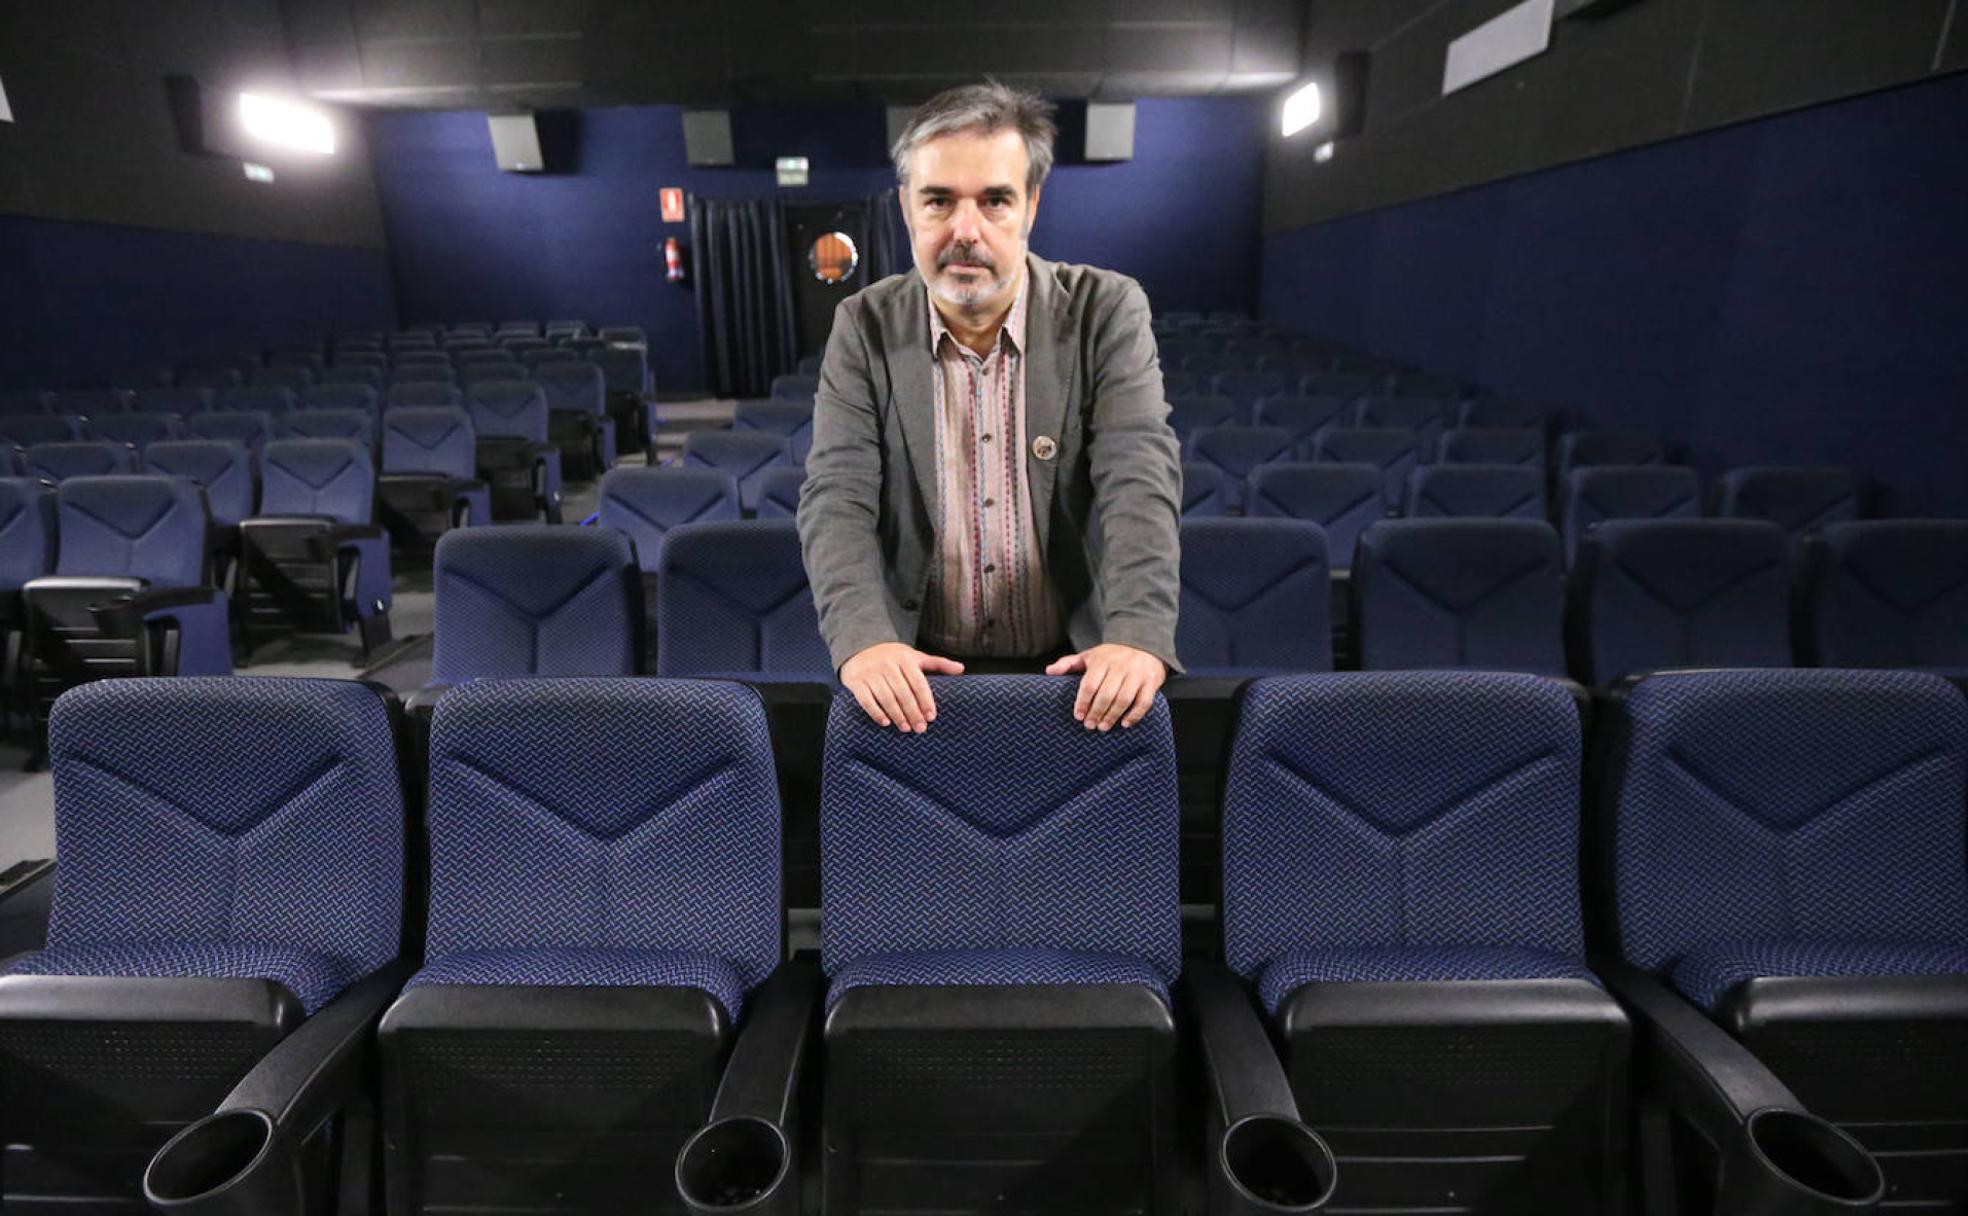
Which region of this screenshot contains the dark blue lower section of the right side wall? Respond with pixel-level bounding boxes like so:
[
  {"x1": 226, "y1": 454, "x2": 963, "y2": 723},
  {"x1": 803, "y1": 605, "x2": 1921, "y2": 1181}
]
[{"x1": 1261, "y1": 75, "x2": 1968, "y2": 516}]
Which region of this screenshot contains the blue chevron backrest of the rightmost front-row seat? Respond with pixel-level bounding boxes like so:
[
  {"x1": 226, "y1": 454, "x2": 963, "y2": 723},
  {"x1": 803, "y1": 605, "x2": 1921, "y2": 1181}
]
[{"x1": 1614, "y1": 671, "x2": 1968, "y2": 970}]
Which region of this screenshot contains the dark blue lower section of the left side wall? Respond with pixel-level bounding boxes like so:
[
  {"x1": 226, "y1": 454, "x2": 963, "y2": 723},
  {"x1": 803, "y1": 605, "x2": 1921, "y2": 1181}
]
[{"x1": 0, "y1": 216, "x2": 396, "y2": 388}]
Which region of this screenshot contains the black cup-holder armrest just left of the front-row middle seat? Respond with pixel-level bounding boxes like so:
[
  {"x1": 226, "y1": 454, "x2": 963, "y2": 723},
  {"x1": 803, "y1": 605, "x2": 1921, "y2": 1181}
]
[{"x1": 677, "y1": 958, "x2": 825, "y2": 1216}]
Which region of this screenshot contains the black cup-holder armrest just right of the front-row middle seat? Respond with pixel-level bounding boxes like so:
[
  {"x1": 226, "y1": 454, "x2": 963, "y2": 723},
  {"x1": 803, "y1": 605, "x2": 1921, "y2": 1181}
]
[{"x1": 1183, "y1": 962, "x2": 1338, "y2": 1216}]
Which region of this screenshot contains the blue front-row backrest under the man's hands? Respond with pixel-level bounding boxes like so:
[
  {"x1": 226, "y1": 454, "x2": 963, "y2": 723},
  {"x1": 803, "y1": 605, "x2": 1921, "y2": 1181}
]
[{"x1": 821, "y1": 675, "x2": 1181, "y2": 980}]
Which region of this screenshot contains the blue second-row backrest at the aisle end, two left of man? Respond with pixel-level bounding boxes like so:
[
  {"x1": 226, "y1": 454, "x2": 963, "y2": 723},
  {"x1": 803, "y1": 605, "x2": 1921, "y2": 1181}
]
[{"x1": 431, "y1": 523, "x2": 642, "y2": 685}]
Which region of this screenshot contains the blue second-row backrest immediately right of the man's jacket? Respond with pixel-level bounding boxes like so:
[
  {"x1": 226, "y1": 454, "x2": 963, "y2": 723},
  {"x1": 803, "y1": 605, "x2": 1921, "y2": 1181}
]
[{"x1": 1175, "y1": 519, "x2": 1332, "y2": 671}]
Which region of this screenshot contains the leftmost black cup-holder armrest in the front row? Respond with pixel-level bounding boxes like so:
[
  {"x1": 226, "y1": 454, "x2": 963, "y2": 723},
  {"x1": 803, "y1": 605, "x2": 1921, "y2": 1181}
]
[{"x1": 144, "y1": 958, "x2": 409, "y2": 1216}]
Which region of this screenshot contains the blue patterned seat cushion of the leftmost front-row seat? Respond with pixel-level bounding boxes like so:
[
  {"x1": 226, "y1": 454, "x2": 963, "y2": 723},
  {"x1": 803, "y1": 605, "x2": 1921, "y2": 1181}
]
[{"x1": 8, "y1": 941, "x2": 360, "y2": 1013}]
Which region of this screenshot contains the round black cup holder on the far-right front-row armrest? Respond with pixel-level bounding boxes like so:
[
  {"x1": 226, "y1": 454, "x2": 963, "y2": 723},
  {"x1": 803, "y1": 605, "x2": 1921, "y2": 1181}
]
[{"x1": 1716, "y1": 1108, "x2": 1885, "y2": 1216}]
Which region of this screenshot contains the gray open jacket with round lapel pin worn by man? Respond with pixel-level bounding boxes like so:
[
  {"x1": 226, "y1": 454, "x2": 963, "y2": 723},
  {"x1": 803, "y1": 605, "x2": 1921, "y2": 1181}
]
[{"x1": 799, "y1": 256, "x2": 1183, "y2": 671}]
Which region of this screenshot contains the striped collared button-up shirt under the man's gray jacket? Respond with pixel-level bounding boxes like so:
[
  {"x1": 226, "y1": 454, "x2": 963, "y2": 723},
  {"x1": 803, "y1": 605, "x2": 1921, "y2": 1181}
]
[{"x1": 919, "y1": 272, "x2": 1065, "y2": 657}]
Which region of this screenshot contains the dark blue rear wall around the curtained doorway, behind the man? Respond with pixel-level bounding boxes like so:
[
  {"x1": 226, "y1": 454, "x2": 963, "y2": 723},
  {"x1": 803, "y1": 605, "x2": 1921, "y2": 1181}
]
[{"x1": 368, "y1": 100, "x2": 1263, "y2": 392}]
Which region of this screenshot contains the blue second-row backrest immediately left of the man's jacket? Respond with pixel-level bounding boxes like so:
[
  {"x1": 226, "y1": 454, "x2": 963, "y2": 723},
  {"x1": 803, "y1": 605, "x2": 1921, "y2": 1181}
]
[{"x1": 655, "y1": 519, "x2": 834, "y2": 679}]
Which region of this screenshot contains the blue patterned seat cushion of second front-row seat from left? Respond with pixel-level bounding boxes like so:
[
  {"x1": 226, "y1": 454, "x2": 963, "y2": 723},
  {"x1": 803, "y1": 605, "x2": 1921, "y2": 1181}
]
[{"x1": 403, "y1": 946, "x2": 744, "y2": 1023}]
